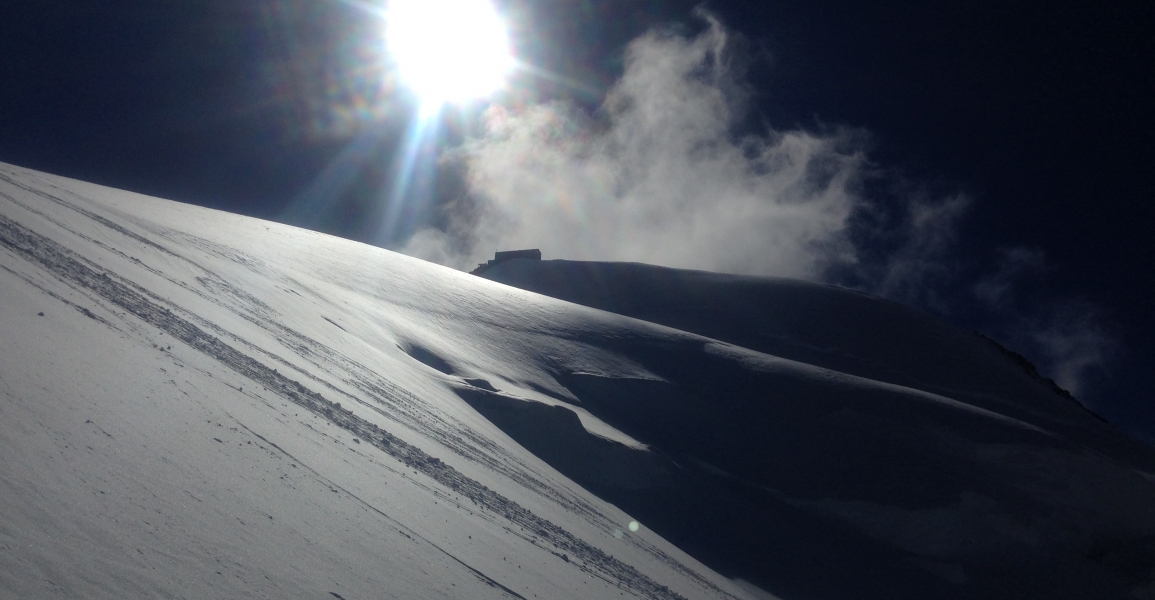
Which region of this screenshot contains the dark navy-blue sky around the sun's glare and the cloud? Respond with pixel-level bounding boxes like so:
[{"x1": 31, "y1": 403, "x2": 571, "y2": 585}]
[{"x1": 0, "y1": 0, "x2": 1155, "y2": 437}]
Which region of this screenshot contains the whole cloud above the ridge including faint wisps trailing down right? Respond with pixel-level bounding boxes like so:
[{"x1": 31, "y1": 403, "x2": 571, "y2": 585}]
[{"x1": 402, "y1": 13, "x2": 1116, "y2": 403}]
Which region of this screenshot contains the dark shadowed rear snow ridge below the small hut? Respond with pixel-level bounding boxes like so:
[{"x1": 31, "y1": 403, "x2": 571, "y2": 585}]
[{"x1": 482, "y1": 260, "x2": 1155, "y2": 464}]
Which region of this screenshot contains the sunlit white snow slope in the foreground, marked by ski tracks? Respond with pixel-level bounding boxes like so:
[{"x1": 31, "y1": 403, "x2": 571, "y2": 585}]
[{"x1": 0, "y1": 166, "x2": 746, "y2": 599}]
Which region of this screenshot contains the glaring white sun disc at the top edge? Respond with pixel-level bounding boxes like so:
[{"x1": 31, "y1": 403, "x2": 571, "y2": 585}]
[{"x1": 385, "y1": 0, "x2": 513, "y2": 106}]
